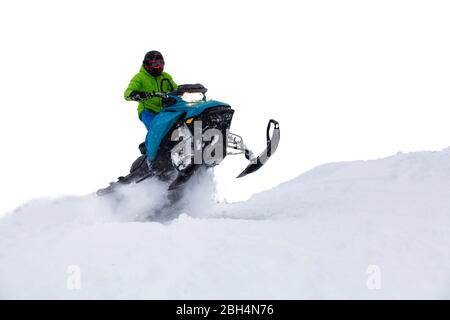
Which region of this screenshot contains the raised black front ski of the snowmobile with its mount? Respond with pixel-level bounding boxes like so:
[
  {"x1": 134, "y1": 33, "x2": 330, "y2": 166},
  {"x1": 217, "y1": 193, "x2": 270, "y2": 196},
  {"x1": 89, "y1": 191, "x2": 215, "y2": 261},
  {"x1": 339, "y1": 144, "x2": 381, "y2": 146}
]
[{"x1": 235, "y1": 119, "x2": 280, "y2": 178}]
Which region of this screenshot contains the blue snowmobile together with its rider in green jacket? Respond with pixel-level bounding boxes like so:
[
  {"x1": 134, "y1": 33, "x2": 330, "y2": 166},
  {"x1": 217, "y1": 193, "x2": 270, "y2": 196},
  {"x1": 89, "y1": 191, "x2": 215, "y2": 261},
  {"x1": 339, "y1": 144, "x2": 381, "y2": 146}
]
[{"x1": 97, "y1": 51, "x2": 280, "y2": 196}]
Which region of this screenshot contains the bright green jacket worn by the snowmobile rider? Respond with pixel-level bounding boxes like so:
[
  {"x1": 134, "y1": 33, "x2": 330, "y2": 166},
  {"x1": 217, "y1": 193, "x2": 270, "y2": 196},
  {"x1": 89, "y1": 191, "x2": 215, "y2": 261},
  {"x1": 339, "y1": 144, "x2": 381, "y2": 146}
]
[{"x1": 124, "y1": 66, "x2": 177, "y2": 118}]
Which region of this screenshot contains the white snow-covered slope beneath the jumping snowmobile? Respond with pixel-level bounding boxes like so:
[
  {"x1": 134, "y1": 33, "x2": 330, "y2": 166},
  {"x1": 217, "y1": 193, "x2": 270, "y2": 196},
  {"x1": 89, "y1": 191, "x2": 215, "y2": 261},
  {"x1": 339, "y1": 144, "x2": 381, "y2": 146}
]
[{"x1": 0, "y1": 148, "x2": 450, "y2": 299}]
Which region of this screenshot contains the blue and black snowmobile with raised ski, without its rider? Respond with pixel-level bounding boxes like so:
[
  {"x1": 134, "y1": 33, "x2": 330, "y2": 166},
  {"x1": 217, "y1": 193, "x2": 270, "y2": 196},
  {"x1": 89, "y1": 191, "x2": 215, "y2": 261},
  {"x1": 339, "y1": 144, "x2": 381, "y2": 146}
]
[{"x1": 97, "y1": 84, "x2": 280, "y2": 196}]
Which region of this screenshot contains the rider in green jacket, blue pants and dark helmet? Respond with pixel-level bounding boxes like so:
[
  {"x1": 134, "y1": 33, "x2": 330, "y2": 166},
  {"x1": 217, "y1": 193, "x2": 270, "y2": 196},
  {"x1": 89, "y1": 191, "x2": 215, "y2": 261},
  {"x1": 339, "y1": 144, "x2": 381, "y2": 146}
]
[{"x1": 124, "y1": 50, "x2": 178, "y2": 170}]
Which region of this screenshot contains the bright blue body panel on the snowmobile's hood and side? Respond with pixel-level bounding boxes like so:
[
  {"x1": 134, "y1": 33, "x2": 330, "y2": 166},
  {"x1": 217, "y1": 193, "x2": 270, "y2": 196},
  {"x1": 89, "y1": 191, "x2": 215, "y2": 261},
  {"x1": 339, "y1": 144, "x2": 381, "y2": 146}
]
[{"x1": 147, "y1": 97, "x2": 231, "y2": 161}]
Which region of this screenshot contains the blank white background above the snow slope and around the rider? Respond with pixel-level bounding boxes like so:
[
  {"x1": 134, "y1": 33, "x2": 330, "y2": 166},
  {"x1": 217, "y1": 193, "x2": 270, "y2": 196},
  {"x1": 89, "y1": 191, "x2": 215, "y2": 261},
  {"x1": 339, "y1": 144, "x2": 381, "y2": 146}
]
[{"x1": 0, "y1": 0, "x2": 450, "y2": 213}]
